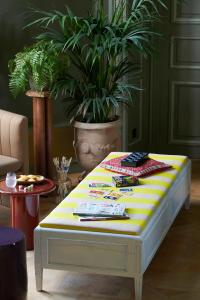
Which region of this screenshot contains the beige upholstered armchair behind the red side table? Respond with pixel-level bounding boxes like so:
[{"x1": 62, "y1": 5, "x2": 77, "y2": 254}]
[{"x1": 0, "y1": 109, "x2": 29, "y2": 206}]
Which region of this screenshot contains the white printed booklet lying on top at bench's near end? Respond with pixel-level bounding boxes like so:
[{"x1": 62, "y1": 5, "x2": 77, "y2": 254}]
[{"x1": 73, "y1": 201, "x2": 125, "y2": 217}]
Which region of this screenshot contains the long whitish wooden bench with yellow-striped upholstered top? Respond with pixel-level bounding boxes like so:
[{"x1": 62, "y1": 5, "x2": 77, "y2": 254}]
[{"x1": 35, "y1": 152, "x2": 190, "y2": 300}]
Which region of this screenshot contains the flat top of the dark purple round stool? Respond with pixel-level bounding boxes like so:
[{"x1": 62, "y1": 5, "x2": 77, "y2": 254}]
[{"x1": 0, "y1": 227, "x2": 24, "y2": 246}]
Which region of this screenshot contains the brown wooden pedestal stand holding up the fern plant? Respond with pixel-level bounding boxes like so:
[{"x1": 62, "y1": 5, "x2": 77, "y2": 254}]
[{"x1": 26, "y1": 90, "x2": 53, "y2": 178}]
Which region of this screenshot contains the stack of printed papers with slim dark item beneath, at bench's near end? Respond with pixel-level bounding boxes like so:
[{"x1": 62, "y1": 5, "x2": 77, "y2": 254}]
[{"x1": 73, "y1": 202, "x2": 129, "y2": 221}]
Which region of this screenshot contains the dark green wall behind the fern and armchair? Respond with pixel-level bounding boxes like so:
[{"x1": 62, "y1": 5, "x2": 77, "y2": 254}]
[{"x1": 0, "y1": 0, "x2": 92, "y2": 126}]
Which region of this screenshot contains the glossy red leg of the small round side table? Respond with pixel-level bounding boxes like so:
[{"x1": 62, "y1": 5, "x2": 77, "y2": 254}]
[{"x1": 10, "y1": 195, "x2": 39, "y2": 250}]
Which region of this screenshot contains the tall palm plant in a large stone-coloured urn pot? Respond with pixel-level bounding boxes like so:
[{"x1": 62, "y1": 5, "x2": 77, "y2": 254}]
[{"x1": 25, "y1": 0, "x2": 166, "y2": 171}]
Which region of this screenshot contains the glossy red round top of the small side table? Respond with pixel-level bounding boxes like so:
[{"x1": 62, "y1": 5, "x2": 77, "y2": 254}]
[{"x1": 0, "y1": 178, "x2": 56, "y2": 196}]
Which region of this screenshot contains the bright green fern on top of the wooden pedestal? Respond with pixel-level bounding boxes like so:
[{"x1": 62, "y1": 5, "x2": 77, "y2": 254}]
[{"x1": 9, "y1": 41, "x2": 68, "y2": 96}]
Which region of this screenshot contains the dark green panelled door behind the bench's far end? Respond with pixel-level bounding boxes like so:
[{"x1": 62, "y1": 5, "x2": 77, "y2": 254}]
[{"x1": 150, "y1": 0, "x2": 200, "y2": 158}]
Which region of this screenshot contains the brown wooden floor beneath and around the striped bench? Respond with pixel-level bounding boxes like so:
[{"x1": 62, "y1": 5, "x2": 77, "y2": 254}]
[{"x1": 0, "y1": 161, "x2": 200, "y2": 300}]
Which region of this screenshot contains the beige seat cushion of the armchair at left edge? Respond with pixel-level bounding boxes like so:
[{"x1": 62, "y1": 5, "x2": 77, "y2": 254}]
[{"x1": 0, "y1": 155, "x2": 22, "y2": 176}]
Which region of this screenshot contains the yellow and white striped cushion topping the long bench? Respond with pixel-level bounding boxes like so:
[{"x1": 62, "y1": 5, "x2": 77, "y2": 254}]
[{"x1": 40, "y1": 152, "x2": 187, "y2": 235}]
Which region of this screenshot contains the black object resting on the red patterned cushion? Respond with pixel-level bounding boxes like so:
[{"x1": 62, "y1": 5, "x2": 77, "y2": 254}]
[{"x1": 121, "y1": 152, "x2": 149, "y2": 167}]
